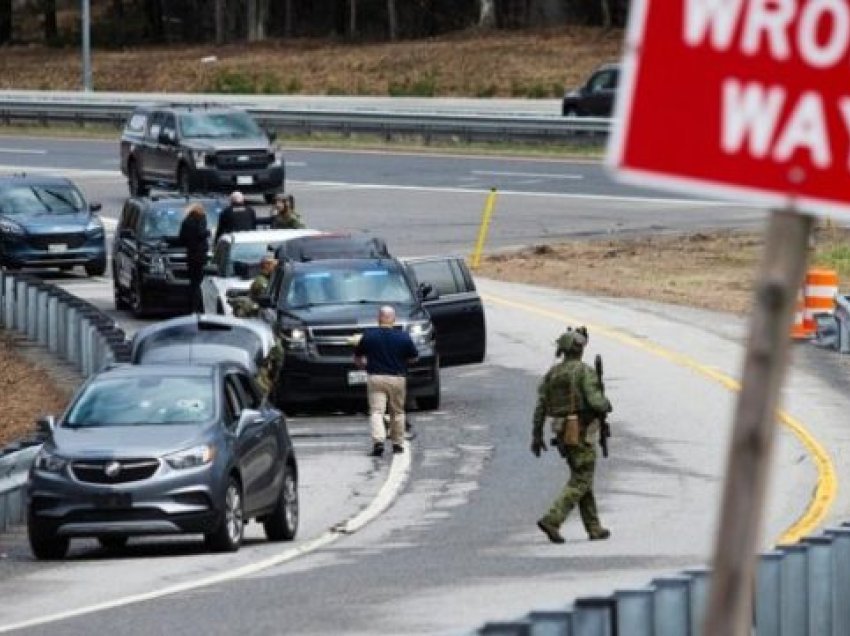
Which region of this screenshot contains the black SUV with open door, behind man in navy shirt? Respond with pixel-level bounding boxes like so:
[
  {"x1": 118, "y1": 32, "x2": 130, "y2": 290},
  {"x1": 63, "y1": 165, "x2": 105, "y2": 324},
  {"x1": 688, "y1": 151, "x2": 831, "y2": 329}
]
[{"x1": 263, "y1": 236, "x2": 486, "y2": 409}]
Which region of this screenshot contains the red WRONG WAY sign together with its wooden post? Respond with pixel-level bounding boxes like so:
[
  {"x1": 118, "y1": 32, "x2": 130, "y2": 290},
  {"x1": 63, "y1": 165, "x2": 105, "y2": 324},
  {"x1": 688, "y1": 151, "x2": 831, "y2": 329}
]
[{"x1": 608, "y1": 0, "x2": 850, "y2": 636}]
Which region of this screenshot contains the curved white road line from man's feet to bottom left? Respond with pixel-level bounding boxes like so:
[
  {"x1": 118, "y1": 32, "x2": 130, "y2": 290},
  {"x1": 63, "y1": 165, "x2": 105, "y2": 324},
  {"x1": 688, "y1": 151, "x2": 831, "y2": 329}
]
[{"x1": 0, "y1": 442, "x2": 411, "y2": 633}]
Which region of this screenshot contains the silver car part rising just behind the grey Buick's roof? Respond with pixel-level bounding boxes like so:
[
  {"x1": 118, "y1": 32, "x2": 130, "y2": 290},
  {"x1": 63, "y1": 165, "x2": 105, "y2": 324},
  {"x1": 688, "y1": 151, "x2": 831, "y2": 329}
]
[{"x1": 130, "y1": 314, "x2": 274, "y2": 375}]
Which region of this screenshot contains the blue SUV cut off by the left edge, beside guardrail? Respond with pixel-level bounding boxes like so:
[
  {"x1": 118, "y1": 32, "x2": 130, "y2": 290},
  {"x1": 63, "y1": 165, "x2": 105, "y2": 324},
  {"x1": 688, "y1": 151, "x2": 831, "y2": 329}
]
[{"x1": 0, "y1": 175, "x2": 106, "y2": 276}]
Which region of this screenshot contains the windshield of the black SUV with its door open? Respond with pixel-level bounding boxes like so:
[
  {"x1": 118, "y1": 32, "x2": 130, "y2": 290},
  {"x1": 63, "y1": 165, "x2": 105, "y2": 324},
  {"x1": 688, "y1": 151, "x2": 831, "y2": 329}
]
[{"x1": 283, "y1": 267, "x2": 414, "y2": 308}]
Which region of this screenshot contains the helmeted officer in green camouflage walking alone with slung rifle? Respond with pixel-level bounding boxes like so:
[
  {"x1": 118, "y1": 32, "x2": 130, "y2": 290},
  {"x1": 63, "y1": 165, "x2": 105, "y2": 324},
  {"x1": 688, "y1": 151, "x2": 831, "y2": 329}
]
[{"x1": 531, "y1": 328, "x2": 611, "y2": 543}]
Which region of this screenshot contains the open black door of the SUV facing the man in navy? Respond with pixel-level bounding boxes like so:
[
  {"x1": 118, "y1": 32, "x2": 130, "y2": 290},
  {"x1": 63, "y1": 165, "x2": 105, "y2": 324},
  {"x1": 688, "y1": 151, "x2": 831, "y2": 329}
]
[{"x1": 402, "y1": 256, "x2": 486, "y2": 367}]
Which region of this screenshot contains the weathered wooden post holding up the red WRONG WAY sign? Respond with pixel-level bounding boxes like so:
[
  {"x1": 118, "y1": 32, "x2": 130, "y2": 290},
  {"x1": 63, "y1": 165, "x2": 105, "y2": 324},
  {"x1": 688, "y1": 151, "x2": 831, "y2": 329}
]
[{"x1": 704, "y1": 212, "x2": 813, "y2": 636}]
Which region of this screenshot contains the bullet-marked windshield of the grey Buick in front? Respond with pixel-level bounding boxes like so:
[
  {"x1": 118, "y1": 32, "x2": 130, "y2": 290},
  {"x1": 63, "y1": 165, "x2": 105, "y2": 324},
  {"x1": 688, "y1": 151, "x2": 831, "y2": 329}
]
[{"x1": 64, "y1": 375, "x2": 215, "y2": 428}]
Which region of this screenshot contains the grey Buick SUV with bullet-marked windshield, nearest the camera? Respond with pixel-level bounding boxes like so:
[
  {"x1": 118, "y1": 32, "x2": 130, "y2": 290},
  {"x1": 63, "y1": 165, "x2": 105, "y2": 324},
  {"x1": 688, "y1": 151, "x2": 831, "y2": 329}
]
[{"x1": 27, "y1": 362, "x2": 298, "y2": 559}]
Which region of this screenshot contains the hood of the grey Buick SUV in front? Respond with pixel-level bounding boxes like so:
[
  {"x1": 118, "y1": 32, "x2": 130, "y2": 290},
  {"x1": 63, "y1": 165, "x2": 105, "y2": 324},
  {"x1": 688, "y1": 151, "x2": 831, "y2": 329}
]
[{"x1": 52, "y1": 424, "x2": 204, "y2": 459}]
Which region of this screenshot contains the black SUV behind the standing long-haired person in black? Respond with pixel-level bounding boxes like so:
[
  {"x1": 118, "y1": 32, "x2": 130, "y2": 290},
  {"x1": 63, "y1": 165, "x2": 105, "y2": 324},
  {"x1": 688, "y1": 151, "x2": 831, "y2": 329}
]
[{"x1": 112, "y1": 197, "x2": 227, "y2": 316}]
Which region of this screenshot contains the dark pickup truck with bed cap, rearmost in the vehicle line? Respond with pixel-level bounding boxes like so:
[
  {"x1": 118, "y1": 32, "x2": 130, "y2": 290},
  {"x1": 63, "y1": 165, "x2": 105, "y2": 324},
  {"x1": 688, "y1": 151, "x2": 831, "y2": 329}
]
[{"x1": 121, "y1": 104, "x2": 284, "y2": 203}]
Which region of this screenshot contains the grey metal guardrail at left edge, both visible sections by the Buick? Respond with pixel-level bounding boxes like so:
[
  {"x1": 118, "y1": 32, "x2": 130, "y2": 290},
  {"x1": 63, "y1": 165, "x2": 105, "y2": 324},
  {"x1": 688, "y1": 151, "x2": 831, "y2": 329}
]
[{"x1": 0, "y1": 270, "x2": 130, "y2": 532}]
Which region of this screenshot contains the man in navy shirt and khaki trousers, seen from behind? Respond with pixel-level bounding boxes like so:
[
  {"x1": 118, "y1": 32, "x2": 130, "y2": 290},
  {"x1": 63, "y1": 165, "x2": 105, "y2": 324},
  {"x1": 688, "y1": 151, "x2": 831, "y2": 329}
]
[{"x1": 354, "y1": 305, "x2": 419, "y2": 457}]
